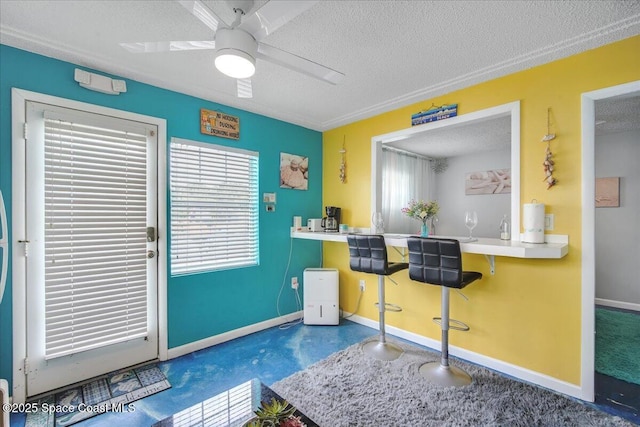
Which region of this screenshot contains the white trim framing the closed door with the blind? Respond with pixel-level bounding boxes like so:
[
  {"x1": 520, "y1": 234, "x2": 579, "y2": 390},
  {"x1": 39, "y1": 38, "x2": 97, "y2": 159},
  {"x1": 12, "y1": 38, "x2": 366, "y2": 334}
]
[{"x1": 11, "y1": 88, "x2": 168, "y2": 403}]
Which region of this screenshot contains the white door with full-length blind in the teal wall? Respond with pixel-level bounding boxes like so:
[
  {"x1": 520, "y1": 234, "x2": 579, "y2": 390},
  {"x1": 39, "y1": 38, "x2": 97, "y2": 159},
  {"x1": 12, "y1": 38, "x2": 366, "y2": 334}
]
[{"x1": 24, "y1": 102, "x2": 158, "y2": 396}]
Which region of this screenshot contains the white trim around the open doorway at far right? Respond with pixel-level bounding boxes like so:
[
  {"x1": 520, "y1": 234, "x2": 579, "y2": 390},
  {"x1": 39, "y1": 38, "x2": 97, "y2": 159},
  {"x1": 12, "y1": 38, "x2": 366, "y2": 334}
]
[{"x1": 580, "y1": 80, "x2": 640, "y2": 402}]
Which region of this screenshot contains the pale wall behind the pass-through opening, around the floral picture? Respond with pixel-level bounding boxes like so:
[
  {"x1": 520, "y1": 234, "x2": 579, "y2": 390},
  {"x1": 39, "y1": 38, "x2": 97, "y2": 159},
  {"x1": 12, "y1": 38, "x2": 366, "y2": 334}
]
[{"x1": 435, "y1": 150, "x2": 511, "y2": 238}]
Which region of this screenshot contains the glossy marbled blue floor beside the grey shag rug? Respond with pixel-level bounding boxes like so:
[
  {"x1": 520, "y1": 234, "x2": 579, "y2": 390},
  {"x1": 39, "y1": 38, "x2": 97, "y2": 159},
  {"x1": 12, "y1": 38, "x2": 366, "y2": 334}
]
[{"x1": 11, "y1": 319, "x2": 640, "y2": 427}]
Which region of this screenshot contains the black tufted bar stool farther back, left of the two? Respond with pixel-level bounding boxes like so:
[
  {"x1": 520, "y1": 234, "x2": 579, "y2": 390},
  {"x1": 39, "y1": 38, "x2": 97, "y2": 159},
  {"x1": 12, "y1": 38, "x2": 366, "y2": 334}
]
[{"x1": 347, "y1": 234, "x2": 409, "y2": 360}]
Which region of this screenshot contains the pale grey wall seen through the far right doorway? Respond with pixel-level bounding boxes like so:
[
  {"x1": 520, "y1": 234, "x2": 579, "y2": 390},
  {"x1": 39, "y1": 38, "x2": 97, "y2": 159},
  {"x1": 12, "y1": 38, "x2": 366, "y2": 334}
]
[{"x1": 595, "y1": 131, "x2": 640, "y2": 304}]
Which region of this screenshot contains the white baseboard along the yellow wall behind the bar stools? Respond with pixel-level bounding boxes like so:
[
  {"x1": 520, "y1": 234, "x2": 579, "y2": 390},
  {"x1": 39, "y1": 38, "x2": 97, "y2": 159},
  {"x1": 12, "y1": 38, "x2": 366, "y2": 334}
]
[{"x1": 344, "y1": 312, "x2": 583, "y2": 399}]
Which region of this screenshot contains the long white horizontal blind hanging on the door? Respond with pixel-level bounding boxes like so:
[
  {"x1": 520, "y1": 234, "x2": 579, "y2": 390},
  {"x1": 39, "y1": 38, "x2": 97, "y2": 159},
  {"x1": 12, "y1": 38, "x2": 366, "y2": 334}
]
[{"x1": 44, "y1": 113, "x2": 147, "y2": 359}]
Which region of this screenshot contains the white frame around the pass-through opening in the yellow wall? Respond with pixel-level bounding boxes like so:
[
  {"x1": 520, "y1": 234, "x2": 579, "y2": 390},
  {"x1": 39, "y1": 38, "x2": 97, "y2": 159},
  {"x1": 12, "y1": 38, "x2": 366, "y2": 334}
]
[{"x1": 371, "y1": 101, "x2": 520, "y2": 241}]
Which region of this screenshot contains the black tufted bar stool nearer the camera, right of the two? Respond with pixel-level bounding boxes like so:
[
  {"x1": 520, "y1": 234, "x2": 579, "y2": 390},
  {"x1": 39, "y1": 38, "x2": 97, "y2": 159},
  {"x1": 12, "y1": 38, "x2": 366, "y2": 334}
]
[{"x1": 407, "y1": 237, "x2": 482, "y2": 387}]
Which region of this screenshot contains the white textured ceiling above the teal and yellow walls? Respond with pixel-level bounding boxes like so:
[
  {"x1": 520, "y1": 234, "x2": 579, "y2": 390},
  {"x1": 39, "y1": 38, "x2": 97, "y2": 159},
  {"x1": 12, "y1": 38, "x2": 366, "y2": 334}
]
[{"x1": 0, "y1": 0, "x2": 640, "y2": 130}]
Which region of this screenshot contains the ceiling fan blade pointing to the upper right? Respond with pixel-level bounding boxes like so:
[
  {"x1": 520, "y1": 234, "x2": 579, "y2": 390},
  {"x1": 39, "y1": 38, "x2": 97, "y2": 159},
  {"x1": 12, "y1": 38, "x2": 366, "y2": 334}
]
[{"x1": 238, "y1": 0, "x2": 317, "y2": 40}]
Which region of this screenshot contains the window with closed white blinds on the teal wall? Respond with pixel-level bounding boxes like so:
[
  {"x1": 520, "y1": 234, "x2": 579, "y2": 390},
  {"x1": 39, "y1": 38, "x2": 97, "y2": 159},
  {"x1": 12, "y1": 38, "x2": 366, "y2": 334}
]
[{"x1": 170, "y1": 138, "x2": 259, "y2": 275}]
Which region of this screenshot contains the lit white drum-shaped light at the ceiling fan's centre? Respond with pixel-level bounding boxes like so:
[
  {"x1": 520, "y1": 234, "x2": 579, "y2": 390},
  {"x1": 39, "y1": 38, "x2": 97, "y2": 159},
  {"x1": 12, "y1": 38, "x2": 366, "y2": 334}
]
[{"x1": 215, "y1": 28, "x2": 258, "y2": 79}]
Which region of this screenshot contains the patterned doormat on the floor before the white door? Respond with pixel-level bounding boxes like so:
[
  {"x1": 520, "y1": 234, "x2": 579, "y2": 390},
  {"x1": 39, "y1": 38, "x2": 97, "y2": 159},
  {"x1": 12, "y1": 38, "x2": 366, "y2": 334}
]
[{"x1": 25, "y1": 364, "x2": 171, "y2": 427}]
